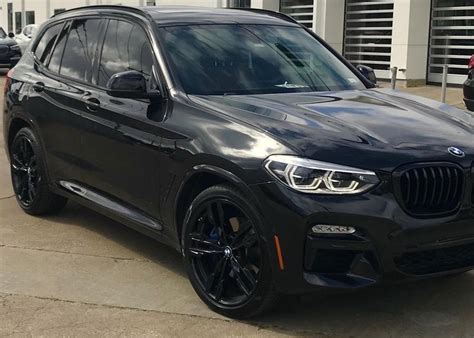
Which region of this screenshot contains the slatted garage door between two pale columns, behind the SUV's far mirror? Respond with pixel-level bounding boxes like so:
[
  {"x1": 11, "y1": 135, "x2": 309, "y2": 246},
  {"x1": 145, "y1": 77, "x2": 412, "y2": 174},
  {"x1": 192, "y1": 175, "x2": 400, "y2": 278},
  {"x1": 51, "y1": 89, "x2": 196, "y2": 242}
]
[{"x1": 344, "y1": 0, "x2": 394, "y2": 78}]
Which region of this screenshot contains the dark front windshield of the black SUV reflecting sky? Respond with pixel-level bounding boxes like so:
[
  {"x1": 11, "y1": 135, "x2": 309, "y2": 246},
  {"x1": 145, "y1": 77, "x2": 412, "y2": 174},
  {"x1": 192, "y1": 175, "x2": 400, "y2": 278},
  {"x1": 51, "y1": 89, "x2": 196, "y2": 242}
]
[{"x1": 160, "y1": 25, "x2": 366, "y2": 95}]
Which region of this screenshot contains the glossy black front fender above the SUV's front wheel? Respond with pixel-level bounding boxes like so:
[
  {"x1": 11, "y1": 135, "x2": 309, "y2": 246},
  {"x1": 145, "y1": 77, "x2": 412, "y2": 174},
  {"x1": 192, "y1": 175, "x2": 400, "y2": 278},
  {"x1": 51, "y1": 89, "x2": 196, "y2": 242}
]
[{"x1": 160, "y1": 95, "x2": 293, "y2": 243}]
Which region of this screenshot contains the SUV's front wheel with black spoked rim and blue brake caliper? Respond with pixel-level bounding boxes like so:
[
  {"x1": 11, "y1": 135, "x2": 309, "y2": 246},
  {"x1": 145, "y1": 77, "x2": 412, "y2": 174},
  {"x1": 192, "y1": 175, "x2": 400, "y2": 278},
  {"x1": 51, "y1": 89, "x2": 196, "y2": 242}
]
[{"x1": 182, "y1": 185, "x2": 279, "y2": 319}]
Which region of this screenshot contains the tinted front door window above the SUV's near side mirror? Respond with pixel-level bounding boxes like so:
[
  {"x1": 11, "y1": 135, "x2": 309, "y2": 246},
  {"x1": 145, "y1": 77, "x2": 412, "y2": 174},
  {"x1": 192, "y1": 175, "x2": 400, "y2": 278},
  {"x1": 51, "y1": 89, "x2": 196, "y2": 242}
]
[{"x1": 98, "y1": 20, "x2": 153, "y2": 87}]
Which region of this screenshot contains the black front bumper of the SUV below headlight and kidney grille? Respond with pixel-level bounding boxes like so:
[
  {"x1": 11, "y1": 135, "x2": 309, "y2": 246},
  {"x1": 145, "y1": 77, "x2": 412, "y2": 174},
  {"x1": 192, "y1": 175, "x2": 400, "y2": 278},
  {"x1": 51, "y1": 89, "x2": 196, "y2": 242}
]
[{"x1": 252, "y1": 182, "x2": 474, "y2": 294}]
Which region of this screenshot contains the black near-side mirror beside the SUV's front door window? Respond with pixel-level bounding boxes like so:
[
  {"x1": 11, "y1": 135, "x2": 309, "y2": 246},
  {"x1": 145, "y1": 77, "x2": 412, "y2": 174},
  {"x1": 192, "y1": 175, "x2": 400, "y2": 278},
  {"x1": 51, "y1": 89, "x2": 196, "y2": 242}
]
[{"x1": 107, "y1": 70, "x2": 159, "y2": 99}]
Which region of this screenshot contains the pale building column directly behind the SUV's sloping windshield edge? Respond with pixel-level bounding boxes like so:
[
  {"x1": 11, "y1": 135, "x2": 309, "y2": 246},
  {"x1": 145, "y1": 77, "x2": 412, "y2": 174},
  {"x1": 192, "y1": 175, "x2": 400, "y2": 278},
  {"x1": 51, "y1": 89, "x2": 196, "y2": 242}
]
[{"x1": 313, "y1": 0, "x2": 345, "y2": 53}]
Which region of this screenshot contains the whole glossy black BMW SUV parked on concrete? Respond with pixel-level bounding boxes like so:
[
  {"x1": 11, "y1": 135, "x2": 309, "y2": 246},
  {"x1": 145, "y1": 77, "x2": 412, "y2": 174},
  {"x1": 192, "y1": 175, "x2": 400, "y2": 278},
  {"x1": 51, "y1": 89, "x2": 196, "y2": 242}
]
[{"x1": 3, "y1": 6, "x2": 474, "y2": 318}]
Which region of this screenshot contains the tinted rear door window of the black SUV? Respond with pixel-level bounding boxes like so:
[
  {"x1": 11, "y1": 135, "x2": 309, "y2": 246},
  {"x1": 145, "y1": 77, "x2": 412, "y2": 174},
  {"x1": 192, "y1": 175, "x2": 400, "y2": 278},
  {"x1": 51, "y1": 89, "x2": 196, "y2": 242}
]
[{"x1": 59, "y1": 19, "x2": 101, "y2": 81}]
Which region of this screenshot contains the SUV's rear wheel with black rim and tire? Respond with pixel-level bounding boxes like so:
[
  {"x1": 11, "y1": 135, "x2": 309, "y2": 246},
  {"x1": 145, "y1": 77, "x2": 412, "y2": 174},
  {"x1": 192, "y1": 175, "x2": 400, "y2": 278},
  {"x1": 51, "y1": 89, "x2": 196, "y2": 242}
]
[{"x1": 9, "y1": 128, "x2": 67, "y2": 215}]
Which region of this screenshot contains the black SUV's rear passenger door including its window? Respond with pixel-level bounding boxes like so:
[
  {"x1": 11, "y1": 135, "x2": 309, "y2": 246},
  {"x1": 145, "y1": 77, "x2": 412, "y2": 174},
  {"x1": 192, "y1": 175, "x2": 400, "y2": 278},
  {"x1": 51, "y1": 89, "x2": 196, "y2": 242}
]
[{"x1": 27, "y1": 18, "x2": 101, "y2": 181}]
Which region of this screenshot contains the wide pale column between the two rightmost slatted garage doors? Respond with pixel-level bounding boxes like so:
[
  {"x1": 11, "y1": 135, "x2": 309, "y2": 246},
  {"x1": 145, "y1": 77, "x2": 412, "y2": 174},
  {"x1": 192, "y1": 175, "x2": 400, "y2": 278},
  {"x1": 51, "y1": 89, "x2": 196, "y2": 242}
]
[{"x1": 390, "y1": 0, "x2": 431, "y2": 87}]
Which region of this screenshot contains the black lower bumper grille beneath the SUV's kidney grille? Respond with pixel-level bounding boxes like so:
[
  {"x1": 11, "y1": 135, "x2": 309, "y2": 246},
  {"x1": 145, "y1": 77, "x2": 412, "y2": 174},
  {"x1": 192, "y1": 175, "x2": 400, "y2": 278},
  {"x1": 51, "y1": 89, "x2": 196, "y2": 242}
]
[{"x1": 395, "y1": 243, "x2": 474, "y2": 275}]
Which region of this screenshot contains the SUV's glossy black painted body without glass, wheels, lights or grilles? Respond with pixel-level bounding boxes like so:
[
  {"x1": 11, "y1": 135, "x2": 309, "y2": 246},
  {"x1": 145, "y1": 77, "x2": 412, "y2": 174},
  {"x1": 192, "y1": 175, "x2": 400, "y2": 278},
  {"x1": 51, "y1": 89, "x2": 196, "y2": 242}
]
[{"x1": 3, "y1": 6, "x2": 474, "y2": 293}]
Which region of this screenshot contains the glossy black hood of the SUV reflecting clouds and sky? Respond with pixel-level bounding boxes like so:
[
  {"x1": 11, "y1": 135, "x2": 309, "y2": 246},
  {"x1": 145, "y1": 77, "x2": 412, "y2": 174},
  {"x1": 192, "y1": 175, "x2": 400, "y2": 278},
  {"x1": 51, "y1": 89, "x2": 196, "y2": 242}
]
[{"x1": 191, "y1": 89, "x2": 474, "y2": 171}]
